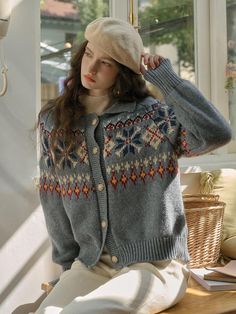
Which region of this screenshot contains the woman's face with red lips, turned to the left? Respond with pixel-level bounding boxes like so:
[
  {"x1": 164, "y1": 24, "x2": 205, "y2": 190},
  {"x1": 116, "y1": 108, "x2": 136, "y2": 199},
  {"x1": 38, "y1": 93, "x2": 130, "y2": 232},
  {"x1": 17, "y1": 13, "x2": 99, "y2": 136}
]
[{"x1": 81, "y1": 42, "x2": 119, "y2": 96}]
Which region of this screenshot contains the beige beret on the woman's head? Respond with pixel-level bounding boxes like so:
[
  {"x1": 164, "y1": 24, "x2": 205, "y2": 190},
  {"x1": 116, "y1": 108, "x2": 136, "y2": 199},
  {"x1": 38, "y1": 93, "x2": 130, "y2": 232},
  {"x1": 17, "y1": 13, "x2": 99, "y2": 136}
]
[{"x1": 84, "y1": 17, "x2": 143, "y2": 74}]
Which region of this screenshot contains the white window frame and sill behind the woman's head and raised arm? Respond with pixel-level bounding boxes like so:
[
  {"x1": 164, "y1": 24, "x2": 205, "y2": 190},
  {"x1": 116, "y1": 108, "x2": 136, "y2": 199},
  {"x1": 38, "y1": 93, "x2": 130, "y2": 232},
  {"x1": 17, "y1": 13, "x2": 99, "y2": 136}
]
[{"x1": 110, "y1": 0, "x2": 236, "y2": 169}]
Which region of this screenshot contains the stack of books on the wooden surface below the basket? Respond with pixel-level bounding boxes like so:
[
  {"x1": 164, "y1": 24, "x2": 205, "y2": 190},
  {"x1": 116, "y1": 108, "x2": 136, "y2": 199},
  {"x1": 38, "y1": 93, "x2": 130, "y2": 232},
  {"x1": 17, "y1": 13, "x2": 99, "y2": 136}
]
[{"x1": 190, "y1": 260, "x2": 236, "y2": 291}]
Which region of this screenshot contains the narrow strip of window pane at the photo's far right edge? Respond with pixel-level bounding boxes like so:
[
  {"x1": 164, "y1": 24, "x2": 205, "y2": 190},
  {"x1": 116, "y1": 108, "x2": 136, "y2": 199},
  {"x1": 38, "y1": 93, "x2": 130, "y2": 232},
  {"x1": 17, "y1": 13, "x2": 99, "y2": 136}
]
[{"x1": 226, "y1": 0, "x2": 236, "y2": 139}]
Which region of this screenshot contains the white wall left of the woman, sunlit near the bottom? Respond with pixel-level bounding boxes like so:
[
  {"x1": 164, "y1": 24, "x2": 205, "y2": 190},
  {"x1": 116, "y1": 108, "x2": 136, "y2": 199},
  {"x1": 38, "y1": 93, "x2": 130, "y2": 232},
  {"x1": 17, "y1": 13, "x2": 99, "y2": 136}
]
[{"x1": 0, "y1": 0, "x2": 58, "y2": 314}]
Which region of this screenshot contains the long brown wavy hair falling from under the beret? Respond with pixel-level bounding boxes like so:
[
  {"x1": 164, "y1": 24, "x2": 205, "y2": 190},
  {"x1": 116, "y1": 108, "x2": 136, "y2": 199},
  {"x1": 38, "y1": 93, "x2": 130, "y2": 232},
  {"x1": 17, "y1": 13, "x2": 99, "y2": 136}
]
[{"x1": 38, "y1": 41, "x2": 151, "y2": 153}]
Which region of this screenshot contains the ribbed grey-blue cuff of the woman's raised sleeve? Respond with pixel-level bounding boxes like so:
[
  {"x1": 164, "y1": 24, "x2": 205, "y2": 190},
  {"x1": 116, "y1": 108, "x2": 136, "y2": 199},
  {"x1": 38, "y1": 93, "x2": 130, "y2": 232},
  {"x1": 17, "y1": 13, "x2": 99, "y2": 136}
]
[{"x1": 144, "y1": 59, "x2": 183, "y2": 96}]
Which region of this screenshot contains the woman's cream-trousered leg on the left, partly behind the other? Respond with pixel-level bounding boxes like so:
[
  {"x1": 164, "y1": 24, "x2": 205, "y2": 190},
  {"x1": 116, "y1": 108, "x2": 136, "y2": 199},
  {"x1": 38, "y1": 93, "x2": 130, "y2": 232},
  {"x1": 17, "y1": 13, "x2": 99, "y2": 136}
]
[{"x1": 35, "y1": 261, "x2": 110, "y2": 314}]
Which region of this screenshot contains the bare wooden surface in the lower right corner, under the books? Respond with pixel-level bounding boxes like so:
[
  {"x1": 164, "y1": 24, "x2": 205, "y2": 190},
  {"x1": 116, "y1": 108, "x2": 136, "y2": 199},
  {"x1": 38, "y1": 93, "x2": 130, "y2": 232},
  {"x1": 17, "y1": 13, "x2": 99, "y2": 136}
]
[{"x1": 161, "y1": 278, "x2": 236, "y2": 314}]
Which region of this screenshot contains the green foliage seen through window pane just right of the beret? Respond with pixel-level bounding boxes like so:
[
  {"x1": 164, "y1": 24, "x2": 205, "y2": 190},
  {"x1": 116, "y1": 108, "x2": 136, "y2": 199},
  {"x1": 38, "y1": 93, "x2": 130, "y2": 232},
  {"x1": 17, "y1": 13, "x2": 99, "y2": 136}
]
[{"x1": 139, "y1": 0, "x2": 194, "y2": 69}]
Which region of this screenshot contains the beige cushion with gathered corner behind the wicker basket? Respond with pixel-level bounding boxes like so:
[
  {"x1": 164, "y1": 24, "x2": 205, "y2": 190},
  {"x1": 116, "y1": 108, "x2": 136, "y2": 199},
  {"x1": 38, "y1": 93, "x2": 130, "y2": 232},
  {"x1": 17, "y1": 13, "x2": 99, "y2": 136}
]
[{"x1": 200, "y1": 169, "x2": 236, "y2": 259}]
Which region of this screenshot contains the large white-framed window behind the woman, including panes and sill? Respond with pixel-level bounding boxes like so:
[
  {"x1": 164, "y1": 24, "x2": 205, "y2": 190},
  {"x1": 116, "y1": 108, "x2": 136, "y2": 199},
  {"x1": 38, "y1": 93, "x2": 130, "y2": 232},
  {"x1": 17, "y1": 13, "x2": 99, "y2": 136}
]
[{"x1": 41, "y1": 0, "x2": 236, "y2": 167}]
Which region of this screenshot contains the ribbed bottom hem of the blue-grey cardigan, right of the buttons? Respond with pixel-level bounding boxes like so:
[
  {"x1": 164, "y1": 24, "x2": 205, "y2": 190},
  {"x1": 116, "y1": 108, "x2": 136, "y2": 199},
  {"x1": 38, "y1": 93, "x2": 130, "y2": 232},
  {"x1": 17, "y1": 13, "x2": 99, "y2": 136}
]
[{"x1": 117, "y1": 237, "x2": 189, "y2": 266}]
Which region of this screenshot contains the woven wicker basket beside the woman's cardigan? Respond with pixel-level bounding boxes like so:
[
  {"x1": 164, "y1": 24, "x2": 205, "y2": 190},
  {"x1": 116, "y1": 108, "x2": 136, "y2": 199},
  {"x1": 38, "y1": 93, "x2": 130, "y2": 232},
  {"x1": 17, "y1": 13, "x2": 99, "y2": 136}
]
[{"x1": 183, "y1": 194, "x2": 225, "y2": 268}]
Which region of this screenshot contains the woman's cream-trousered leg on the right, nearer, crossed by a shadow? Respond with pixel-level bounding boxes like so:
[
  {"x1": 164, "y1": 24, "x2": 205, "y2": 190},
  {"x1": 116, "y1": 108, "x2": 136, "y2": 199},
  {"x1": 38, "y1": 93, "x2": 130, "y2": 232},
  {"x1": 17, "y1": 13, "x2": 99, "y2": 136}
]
[{"x1": 61, "y1": 261, "x2": 189, "y2": 314}]
